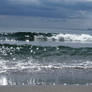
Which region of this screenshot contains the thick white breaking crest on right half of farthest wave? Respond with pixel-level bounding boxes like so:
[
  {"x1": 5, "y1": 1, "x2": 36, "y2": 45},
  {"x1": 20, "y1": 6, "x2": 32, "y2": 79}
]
[{"x1": 48, "y1": 33, "x2": 92, "y2": 42}]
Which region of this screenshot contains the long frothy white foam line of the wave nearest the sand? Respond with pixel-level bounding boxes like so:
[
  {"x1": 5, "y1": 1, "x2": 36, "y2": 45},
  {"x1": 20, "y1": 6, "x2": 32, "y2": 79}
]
[{"x1": 0, "y1": 60, "x2": 92, "y2": 73}]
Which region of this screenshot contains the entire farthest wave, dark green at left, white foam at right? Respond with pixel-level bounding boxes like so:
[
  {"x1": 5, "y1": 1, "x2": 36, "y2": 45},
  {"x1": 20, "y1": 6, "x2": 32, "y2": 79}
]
[{"x1": 0, "y1": 32, "x2": 92, "y2": 42}]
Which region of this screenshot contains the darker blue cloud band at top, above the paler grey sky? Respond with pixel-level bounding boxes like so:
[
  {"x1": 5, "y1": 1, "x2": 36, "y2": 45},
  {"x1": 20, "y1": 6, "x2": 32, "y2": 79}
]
[{"x1": 0, "y1": 0, "x2": 92, "y2": 18}]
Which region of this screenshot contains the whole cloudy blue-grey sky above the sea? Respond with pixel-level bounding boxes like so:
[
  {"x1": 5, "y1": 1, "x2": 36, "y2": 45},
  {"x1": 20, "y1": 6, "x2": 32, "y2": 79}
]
[{"x1": 0, "y1": 0, "x2": 92, "y2": 29}]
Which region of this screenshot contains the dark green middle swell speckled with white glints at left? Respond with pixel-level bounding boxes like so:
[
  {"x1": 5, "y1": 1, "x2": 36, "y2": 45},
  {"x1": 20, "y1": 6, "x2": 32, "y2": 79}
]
[{"x1": 0, "y1": 44, "x2": 92, "y2": 59}]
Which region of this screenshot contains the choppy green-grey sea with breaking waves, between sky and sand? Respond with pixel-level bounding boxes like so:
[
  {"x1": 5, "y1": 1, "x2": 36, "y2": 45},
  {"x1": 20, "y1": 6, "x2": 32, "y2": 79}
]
[{"x1": 0, "y1": 29, "x2": 92, "y2": 85}]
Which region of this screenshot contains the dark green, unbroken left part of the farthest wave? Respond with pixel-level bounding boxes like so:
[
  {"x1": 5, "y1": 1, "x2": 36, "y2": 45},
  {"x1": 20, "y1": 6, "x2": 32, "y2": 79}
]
[{"x1": 0, "y1": 32, "x2": 52, "y2": 41}]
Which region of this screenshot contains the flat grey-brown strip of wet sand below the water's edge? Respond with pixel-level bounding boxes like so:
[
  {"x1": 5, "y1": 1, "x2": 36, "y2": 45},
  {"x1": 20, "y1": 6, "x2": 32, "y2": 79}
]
[{"x1": 0, "y1": 86, "x2": 92, "y2": 92}]
